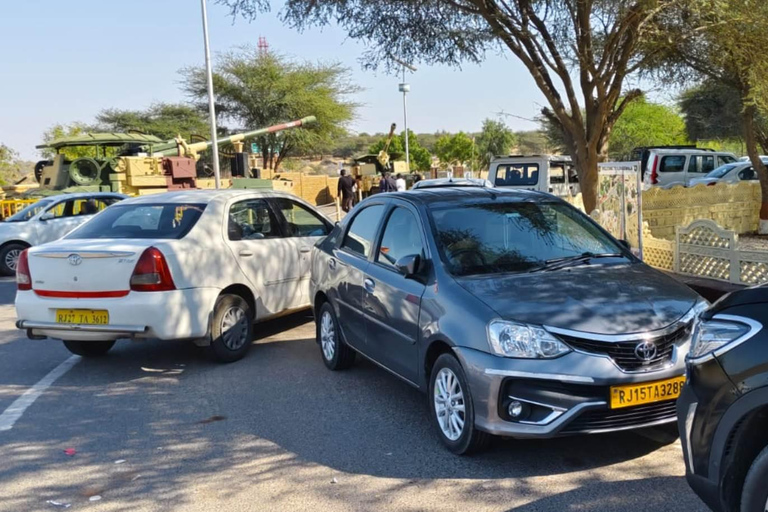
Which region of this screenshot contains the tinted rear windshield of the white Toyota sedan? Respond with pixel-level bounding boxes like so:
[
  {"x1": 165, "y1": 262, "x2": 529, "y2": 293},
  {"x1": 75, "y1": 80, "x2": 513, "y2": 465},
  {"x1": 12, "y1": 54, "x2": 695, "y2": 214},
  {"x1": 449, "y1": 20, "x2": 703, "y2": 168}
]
[{"x1": 65, "y1": 203, "x2": 205, "y2": 240}]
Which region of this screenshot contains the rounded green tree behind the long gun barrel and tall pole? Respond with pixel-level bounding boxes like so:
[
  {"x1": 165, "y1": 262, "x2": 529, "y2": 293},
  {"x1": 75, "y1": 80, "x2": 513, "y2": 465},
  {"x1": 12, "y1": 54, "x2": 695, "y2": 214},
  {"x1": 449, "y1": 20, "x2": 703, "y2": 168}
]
[{"x1": 181, "y1": 47, "x2": 360, "y2": 169}]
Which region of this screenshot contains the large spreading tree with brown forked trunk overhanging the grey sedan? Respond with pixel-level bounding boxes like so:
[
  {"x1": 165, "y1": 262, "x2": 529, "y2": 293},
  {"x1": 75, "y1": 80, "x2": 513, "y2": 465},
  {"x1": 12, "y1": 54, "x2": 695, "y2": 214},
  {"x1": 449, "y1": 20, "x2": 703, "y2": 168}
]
[{"x1": 218, "y1": 0, "x2": 679, "y2": 211}]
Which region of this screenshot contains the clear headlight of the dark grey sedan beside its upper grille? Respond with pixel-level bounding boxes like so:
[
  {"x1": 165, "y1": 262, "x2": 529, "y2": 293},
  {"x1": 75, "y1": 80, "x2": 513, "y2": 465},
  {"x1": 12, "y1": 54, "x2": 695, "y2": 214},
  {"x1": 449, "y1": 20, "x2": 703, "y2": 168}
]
[{"x1": 488, "y1": 320, "x2": 571, "y2": 359}]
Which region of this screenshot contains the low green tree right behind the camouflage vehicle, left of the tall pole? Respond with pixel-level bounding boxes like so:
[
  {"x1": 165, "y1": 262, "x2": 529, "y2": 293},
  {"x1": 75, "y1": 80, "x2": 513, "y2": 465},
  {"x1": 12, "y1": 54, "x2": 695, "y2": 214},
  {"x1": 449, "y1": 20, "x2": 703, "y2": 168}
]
[{"x1": 96, "y1": 103, "x2": 210, "y2": 140}]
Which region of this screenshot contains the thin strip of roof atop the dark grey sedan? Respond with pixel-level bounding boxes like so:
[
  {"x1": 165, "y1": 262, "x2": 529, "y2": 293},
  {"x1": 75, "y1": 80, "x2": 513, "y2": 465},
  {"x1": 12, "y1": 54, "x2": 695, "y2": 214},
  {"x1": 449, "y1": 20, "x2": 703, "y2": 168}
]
[{"x1": 384, "y1": 186, "x2": 556, "y2": 206}]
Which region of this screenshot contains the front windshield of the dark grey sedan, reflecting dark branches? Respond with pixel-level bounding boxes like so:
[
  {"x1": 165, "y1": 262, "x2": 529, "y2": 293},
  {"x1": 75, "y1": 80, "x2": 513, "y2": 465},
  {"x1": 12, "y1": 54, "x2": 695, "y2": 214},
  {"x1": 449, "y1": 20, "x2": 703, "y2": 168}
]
[{"x1": 432, "y1": 202, "x2": 624, "y2": 276}]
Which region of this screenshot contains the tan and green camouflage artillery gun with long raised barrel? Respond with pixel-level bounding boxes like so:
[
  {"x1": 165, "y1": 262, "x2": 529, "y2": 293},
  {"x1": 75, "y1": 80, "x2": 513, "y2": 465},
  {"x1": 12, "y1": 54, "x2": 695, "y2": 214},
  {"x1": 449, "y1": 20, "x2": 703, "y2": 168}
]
[{"x1": 35, "y1": 116, "x2": 316, "y2": 194}]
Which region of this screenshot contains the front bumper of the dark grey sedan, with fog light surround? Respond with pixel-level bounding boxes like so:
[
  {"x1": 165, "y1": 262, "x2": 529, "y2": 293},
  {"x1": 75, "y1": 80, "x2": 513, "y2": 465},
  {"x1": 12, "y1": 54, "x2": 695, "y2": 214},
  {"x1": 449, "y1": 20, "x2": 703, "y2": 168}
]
[{"x1": 454, "y1": 347, "x2": 685, "y2": 438}]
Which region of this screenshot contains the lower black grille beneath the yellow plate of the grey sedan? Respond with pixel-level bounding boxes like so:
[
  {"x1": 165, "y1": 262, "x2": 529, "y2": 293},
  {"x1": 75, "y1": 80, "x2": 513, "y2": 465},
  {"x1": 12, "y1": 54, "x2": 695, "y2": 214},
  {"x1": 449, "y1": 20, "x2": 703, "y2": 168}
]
[{"x1": 560, "y1": 400, "x2": 677, "y2": 434}]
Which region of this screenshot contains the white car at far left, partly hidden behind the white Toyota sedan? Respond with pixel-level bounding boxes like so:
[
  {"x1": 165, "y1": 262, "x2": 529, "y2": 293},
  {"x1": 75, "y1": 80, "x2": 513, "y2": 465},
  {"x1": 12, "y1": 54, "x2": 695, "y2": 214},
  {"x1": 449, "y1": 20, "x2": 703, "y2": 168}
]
[{"x1": 0, "y1": 192, "x2": 128, "y2": 276}]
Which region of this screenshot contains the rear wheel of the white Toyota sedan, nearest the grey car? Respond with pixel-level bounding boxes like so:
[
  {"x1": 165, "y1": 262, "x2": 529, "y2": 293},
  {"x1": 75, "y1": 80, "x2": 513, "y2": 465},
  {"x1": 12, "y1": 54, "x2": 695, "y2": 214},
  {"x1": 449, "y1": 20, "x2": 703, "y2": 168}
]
[{"x1": 209, "y1": 295, "x2": 253, "y2": 363}]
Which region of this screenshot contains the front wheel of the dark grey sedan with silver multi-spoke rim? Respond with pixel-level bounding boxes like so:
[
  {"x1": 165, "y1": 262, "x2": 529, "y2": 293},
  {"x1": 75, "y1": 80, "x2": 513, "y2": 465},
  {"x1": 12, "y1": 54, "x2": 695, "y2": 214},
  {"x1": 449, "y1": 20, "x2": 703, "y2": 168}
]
[{"x1": 428, "y1": 354, "x2": 491, "y2": 455}]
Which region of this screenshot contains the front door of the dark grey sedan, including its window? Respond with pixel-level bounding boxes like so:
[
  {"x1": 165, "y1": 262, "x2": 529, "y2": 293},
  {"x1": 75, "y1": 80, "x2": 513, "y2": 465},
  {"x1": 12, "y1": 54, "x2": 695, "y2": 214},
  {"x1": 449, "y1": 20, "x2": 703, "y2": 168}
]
[{"x1": 364, "y1": 203, "x2": 425, "y2": 382}]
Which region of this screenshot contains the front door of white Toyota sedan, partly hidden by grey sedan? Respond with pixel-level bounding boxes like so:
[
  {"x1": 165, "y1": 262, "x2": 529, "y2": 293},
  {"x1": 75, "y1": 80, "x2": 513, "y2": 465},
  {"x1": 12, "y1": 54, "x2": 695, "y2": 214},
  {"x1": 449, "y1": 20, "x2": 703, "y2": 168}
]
[{"x1": 269, "y1": 197, "x2": 331, "y2": 308}]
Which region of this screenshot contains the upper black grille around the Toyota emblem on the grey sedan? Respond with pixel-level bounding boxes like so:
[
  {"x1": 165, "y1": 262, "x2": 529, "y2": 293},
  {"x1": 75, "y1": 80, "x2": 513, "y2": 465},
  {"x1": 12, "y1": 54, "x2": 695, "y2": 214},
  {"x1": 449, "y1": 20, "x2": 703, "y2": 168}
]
[{"x1": 558, "y1": 322, "x2": 693, "y2": 372}]
